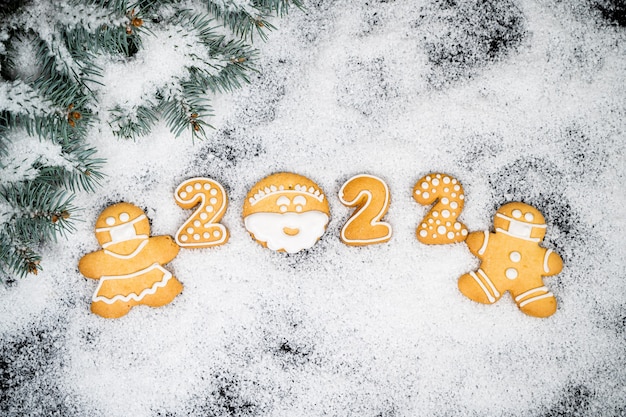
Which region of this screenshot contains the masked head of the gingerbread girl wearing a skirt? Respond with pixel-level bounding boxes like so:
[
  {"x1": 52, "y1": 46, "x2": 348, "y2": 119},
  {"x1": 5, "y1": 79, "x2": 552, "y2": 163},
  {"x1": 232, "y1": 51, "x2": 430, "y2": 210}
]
[{"x1": 96, "y1": 203, "x2": 150, "y2": 252}]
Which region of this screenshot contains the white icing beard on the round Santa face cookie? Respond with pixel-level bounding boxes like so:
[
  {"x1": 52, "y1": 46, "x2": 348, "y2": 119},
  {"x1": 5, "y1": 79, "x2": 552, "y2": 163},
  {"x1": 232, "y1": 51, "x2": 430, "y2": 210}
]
[{"x1": 244, "y1": 211, "x2": 329, "y2": 253}]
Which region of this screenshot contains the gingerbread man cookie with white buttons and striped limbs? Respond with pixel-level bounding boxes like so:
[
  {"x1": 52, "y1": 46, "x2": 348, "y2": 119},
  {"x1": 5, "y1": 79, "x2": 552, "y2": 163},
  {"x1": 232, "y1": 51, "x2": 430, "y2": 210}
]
[{"x1": 458, "y1": 203, "x2": 563, "y2": 317}]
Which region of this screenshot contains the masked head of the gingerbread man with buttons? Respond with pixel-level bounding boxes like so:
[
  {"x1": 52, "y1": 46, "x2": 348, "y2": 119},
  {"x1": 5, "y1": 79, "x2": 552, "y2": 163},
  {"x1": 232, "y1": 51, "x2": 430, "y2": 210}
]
[{"x1": 493, "y1": 202, "x2": 546, "y2": 242}]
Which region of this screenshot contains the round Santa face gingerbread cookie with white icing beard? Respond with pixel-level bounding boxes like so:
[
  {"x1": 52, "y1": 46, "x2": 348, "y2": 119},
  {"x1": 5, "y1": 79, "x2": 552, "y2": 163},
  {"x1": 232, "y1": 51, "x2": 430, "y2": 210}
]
[{"x1": 243, "y1": 172, "x2": 330, "y2": 253}]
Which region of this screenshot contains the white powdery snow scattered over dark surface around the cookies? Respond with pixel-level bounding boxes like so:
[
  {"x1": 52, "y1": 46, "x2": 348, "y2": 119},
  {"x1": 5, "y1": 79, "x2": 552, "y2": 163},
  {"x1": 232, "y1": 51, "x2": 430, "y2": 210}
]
[{"x1": 0, "y1": 0, "x2": 626, "y2": 417}]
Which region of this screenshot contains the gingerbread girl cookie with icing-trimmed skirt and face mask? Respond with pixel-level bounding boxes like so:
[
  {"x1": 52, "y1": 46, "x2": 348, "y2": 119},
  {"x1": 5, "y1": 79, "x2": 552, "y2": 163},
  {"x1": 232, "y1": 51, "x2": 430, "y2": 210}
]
[{"x1": 78, "y1": 203, "x2": 183, "y2": 318}]
